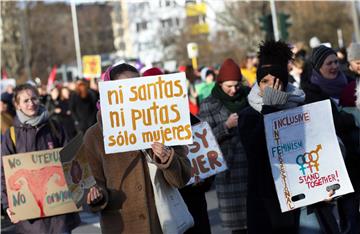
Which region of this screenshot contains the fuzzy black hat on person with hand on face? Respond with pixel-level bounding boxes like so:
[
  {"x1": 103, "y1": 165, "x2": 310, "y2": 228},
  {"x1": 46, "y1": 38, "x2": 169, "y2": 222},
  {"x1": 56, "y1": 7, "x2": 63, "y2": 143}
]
[{"x1": 256, "y1": 40, "x2": 293, "y2": 88}]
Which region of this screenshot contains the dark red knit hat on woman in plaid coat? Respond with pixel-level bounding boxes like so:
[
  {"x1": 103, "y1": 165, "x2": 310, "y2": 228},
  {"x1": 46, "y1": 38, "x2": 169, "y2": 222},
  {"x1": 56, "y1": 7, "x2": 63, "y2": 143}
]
[{"x1": 216, "y1": 58, "x2": 242, "y2": 83}]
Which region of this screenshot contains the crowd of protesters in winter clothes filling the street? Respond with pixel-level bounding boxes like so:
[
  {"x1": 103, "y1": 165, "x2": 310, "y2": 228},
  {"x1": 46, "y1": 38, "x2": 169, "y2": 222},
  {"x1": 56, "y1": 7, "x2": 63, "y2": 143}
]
[{"x1": 0, "y1": 41, "x2": 360, "y2": 234}]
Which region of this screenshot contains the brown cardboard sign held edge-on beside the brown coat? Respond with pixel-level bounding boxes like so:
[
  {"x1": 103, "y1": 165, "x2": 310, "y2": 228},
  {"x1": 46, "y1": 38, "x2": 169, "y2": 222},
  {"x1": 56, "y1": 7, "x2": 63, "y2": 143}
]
[{"x1": 60, "y1": 133, "x2": 96, "y2": 208}]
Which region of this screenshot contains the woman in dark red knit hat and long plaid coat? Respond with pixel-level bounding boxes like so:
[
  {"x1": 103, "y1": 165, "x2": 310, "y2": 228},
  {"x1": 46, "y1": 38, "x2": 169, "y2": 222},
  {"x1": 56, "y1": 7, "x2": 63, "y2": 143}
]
[{"x1": 199, "y1": 58, "x2": 249, "y2": 233}]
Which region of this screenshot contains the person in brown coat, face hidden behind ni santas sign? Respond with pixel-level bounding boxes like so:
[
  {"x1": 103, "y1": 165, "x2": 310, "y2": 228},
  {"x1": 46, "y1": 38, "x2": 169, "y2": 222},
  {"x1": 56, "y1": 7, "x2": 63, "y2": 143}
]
[{"x1": 84, "y1": 63, "x2": 191, "y2": 233}]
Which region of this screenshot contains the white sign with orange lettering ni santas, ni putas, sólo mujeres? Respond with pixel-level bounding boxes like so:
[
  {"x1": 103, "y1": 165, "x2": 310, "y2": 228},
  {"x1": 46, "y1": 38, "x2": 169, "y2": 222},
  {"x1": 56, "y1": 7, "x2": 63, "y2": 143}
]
[{"x1": 99, "y1": 73, "x2": 193, "y2": 154}]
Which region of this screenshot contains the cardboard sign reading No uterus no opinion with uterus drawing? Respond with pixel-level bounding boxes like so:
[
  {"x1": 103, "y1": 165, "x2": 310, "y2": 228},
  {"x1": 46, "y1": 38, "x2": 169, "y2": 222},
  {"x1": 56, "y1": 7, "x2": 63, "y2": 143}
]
[{"x1": 2, "y1": 148, "x2": 79, "y2": 220}]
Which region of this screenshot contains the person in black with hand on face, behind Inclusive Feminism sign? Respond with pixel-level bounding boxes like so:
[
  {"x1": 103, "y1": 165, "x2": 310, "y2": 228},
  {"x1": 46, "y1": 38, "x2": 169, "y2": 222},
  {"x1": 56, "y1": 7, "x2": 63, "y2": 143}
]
[{"x1": 239, "y1": 41, "x2": 305, "y2": 234}]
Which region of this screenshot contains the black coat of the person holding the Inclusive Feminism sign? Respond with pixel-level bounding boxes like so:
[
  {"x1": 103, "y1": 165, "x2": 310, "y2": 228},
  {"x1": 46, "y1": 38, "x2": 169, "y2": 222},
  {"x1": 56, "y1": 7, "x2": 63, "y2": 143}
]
[{"x1": 238, "y1": 105, "x2": 299, "y2": 234}]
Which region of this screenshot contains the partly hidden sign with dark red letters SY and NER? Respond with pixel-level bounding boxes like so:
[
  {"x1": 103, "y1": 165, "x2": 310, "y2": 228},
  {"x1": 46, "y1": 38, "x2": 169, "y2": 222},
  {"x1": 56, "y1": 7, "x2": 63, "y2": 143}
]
[{"x1": 187, "y1": 122, "x2": 227, "y2": 185}]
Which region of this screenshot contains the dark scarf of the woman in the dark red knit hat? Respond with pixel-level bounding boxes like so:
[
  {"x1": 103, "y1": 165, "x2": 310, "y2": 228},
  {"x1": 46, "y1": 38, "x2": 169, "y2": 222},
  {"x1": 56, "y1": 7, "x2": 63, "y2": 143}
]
[{"x1": 211, "y1": 83, "x2": 249, "y2": 113}]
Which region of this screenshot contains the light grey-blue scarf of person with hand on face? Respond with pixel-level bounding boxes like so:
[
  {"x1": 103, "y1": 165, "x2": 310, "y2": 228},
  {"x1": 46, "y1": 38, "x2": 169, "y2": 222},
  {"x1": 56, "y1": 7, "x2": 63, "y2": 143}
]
[{"x1": 248, "y1": 83, "x2": 305, "y2": 112}]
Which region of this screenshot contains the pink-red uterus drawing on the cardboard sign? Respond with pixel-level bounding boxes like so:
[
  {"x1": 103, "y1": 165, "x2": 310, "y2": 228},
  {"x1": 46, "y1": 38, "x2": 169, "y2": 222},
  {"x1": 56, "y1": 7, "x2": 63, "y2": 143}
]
[{"x1": 8, "y1": 166, "x2": 66, "y2": 217}]
